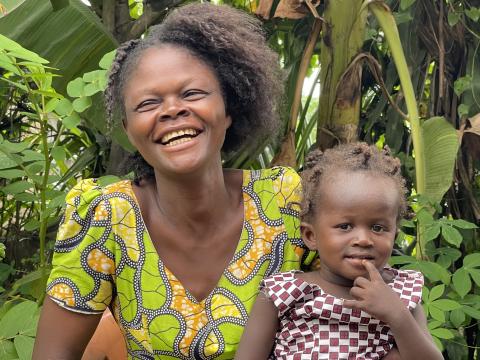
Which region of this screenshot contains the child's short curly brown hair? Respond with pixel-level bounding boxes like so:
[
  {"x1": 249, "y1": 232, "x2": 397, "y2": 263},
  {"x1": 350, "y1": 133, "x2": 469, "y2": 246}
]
[{"x1": 301, "y1": 142, "x2": 407, "y2": 222}]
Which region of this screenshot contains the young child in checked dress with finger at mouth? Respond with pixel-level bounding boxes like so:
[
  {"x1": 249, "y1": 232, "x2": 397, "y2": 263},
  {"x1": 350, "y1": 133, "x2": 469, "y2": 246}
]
[{"x1": 235, "y1": 143, "x2": 443, "y2": 360}]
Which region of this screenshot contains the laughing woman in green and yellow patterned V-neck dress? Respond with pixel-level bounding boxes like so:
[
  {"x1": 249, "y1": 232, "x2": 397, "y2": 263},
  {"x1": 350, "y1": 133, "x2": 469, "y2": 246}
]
[{"x1": 34, "y1": 4, "x2": 308, "y2": 359}]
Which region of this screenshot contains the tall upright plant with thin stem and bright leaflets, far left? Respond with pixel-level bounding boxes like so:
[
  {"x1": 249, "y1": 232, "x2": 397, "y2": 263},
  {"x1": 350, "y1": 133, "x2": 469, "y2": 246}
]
[{"x1": 0, "y1": 35, "x2": 81, "y2": 266}]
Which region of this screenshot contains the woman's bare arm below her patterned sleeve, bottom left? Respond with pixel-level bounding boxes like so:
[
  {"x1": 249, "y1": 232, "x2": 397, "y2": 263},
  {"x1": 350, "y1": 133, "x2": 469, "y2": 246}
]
[{"x1": 32, "y1": 296, "x2": 102, "y2": 360}]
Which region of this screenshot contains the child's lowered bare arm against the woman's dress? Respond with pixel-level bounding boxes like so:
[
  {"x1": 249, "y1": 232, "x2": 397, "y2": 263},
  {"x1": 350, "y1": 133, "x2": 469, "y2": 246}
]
[{"x1": 235, "y1": 292, "x2": 278, "y2": 360}]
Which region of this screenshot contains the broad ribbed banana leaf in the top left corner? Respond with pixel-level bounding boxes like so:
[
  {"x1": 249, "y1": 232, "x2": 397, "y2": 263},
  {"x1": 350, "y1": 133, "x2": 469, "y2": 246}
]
[{"x1": 0, "y1": 0, "x2": 116, "y2": 94}]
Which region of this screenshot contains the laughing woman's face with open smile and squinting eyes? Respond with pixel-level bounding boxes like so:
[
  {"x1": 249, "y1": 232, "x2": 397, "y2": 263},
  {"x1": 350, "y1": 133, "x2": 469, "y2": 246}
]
[{"x1": 123, "y1": 45, "x2": 231, "y2": 175}]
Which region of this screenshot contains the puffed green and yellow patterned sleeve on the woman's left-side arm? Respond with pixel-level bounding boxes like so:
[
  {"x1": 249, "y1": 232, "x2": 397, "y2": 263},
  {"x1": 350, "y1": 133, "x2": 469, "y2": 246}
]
[{"x1": 47, "y1": 179, "x2": 115, "y2": 314}]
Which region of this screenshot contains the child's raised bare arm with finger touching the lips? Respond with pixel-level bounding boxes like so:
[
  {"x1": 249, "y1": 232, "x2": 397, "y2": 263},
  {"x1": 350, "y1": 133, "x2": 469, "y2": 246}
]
[{"x1": 343, "y1": 260, "x2": 443, "y2": 360}]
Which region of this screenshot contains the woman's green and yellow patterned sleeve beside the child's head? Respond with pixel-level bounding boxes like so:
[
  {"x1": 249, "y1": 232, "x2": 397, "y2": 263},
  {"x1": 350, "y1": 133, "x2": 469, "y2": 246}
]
[{"x1": 272, "y1": 167, "x2": 317, "y2": 269}]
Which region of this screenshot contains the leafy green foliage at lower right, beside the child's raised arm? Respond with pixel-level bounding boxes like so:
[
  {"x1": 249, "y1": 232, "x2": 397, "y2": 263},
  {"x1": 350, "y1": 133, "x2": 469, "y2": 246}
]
[{"x1": 390, "y1": 196, "x2": 480, "y2": 350}]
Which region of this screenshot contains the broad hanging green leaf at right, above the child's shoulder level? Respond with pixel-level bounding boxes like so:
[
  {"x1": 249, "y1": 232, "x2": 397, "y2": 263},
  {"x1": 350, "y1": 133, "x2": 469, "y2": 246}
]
[{"x1": 418, "y1": 117, "x2": 459, "y2": 202}]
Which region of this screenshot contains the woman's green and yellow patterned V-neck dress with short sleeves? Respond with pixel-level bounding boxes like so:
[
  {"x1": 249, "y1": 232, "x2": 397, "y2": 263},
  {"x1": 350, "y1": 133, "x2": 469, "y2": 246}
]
[{"x1": 47, "y1": 167, "x2": 313, "y2": 359}]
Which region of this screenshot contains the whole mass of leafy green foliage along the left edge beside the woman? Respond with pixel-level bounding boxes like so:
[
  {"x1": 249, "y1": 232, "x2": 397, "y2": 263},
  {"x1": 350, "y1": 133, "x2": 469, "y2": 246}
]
[{"x1": 0, "y1": 35, "x2": 122, "y2": 352}]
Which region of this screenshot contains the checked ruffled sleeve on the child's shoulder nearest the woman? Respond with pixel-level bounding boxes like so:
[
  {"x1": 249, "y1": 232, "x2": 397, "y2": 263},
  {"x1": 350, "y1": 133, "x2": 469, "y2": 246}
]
[{"x1": 260, "y1": 271, "x2": 312, "y2": 318}]
